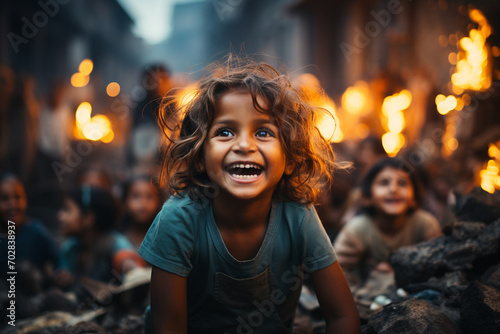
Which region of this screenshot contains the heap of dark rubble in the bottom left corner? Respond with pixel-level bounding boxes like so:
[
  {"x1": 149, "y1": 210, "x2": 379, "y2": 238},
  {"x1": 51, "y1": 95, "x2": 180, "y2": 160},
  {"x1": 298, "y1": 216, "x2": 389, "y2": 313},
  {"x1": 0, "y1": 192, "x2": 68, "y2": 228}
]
[{"x1": 0, "y1": 263, "x2": 151, "y2": 334}]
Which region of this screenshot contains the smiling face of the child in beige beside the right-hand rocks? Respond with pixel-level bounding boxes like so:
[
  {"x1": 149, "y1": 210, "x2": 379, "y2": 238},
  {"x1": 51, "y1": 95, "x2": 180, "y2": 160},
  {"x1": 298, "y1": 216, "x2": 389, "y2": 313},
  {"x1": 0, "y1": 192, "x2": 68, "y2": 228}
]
[{"x1": 371, "y1": 167, "x2": 416, "y2": 216}]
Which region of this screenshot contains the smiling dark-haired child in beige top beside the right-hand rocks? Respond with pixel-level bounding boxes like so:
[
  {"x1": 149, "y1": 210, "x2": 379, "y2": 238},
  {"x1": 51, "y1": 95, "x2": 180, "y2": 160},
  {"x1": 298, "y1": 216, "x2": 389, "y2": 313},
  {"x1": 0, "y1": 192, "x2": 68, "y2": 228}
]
[{"x1": 334, "y1": 158, "x2": 441, "y2": 298}]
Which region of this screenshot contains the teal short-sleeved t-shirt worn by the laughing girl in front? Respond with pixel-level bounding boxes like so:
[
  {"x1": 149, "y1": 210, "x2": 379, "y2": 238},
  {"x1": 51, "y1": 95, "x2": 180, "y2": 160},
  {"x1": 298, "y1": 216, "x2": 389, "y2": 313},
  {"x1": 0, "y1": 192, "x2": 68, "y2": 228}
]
[{"x1": 139, "y1": 196, "x2": 336, "y2": 334}]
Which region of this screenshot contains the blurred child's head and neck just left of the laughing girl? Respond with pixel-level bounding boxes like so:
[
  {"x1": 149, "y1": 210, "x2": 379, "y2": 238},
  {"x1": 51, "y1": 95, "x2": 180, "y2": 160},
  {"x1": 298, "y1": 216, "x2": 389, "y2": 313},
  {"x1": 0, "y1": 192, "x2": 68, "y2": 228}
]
[{"x1": 121, "y1": 175, "x2": 161, "y2": 249}]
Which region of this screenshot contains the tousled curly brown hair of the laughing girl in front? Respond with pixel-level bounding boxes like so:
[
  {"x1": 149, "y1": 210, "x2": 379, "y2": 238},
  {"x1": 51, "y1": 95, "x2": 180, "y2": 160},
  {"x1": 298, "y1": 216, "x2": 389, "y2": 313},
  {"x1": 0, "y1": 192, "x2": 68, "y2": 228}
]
[{"x1": 158, "y1": 54, "x2": 335, "y2": 204}]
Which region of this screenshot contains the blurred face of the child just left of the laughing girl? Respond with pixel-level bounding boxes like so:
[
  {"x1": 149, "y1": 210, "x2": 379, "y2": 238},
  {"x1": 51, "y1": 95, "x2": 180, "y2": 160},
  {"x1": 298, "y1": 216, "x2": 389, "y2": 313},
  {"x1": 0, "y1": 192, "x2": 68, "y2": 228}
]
[{"x1": 125, "y1": 180, "x2": 159, "y2": 224}]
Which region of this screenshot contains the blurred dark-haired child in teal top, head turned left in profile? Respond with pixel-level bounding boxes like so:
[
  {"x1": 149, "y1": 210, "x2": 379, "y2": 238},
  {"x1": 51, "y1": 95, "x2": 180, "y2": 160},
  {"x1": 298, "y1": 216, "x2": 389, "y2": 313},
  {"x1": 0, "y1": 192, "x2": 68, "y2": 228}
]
[{"x1": 58, "y1": 185, "x2": 144, "y2": 286}]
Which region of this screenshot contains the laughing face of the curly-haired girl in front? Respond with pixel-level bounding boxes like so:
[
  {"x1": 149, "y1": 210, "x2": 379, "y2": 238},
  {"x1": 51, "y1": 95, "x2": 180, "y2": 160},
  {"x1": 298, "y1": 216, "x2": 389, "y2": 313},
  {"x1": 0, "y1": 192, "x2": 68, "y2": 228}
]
[{"x1": 203, "y1": 91, "x2": 293, "y2": 200}]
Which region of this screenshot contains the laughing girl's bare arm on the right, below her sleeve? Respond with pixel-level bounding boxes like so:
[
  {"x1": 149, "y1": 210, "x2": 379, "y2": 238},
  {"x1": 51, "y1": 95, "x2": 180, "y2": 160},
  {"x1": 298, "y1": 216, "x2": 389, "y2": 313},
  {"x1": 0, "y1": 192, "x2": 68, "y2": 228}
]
[{"x1": 311, "y1": 261, "x2": 361, "y2": 334}]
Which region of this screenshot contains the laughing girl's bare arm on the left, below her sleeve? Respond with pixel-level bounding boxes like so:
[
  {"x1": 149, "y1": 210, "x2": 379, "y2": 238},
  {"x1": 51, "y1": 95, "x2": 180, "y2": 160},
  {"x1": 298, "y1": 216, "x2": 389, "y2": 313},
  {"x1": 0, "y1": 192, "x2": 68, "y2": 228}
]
[{"x1": 151, "y1": 266, "x2": 187, "y2": 334}]
